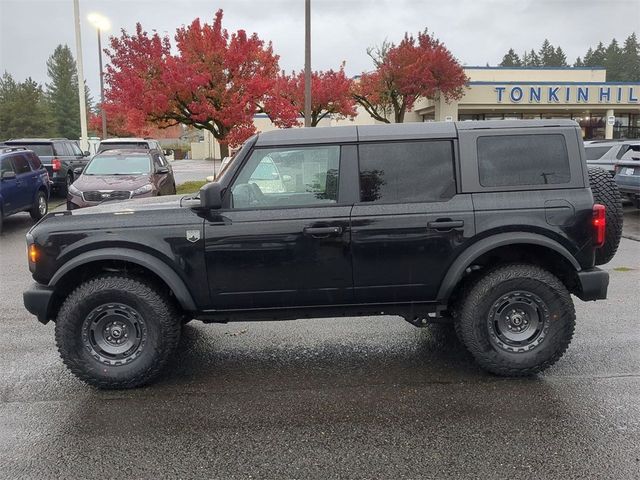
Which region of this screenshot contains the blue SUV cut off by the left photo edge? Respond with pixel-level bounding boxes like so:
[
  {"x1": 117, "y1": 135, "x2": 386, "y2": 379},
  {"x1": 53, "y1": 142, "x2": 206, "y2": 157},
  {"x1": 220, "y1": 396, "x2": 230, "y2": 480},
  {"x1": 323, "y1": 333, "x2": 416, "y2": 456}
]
[{"x1": 0, "y1": 146, "x2": 50, "y2": 233}]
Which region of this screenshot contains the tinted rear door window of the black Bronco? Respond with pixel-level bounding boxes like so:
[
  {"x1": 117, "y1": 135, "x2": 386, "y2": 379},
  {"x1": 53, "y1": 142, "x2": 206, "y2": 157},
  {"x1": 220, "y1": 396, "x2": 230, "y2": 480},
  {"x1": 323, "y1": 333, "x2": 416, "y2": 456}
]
[{"x1": 359, "y1": 140, "x2": 455, "y2": 203}]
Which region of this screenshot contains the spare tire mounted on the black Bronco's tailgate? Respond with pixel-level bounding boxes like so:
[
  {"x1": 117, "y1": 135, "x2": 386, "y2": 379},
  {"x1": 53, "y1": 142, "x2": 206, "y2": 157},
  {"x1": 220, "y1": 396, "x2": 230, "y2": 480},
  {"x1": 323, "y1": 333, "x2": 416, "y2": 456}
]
[{"x1": 589, "y1": 168, "x2": 622, "y2": 265}]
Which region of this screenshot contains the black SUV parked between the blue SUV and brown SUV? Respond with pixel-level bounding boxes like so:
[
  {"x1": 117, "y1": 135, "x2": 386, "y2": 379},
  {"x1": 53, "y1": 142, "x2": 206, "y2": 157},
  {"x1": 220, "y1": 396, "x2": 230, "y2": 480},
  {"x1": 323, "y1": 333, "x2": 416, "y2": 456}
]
[{"x1": 4, "y1": 138, "x2": 89, "y2": 195}]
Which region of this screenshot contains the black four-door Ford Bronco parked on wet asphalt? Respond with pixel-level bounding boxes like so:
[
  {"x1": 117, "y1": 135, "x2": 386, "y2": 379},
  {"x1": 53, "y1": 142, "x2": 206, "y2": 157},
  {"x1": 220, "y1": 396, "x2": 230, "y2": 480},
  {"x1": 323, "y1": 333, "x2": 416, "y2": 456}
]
[{"x1": 24, "y1": 120, "x2": 622, "y2": 388}]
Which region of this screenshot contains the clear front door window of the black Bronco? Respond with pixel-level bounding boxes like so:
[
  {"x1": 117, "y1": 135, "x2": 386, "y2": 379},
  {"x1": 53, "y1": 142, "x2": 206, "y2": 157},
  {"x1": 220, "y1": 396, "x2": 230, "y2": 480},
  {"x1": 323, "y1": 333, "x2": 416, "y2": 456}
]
[{"x1": 231, "y1": 145, "x2": 340, "y2": 208}]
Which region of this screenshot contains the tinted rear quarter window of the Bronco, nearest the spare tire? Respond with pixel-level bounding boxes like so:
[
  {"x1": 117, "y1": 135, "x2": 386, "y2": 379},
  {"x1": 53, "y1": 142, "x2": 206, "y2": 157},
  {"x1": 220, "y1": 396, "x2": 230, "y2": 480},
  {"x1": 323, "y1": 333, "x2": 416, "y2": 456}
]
[{"x1": 477, "y1": 134, "x2": 571, "y2": 187}]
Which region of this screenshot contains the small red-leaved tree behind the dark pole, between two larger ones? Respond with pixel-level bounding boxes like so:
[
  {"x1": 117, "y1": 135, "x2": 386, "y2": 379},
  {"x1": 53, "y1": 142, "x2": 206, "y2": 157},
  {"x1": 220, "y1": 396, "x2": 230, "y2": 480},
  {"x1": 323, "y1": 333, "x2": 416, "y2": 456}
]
[{"x1": 275, "y1": 64, "x2": 357, "y2": 127}]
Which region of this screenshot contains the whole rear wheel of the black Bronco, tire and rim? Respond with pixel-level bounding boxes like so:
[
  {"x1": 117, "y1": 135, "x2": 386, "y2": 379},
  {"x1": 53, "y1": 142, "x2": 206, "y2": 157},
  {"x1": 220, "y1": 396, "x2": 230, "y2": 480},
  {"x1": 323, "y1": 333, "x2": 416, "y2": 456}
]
[{"x1": 455, "y1": 264, "x2": 575, "y2": 376}]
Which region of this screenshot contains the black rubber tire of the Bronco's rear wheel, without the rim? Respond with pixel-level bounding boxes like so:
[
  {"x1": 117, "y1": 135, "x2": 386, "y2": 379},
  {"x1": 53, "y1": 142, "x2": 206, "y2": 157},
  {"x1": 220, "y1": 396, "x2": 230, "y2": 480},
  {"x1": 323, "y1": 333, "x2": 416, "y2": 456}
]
[{"x1": 455, "y1": 264, "x2": 575, "y2": 377}]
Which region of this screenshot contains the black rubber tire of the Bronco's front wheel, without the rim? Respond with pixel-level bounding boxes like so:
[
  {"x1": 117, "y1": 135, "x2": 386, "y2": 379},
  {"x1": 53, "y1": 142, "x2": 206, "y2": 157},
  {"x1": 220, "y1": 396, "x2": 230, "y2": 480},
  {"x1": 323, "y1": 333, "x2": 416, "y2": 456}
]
[{"x1": 55, "y1": 274, "x2": 181, "y2": 389}]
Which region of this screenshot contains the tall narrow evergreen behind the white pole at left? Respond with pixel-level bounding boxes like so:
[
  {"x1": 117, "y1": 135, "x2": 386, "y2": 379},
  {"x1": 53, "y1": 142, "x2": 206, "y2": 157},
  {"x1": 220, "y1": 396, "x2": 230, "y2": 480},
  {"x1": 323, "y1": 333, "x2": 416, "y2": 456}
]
[{"x1": 47, "y1": 45, "x2": 91, "y2": 139}]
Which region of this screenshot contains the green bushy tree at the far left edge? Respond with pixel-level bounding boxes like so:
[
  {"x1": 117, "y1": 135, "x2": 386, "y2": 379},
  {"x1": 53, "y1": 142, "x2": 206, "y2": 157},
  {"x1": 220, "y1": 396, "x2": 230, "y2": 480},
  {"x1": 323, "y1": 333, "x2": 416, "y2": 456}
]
[{"x1": 0, "y1": 72, "x2": 54, "y2": 139}]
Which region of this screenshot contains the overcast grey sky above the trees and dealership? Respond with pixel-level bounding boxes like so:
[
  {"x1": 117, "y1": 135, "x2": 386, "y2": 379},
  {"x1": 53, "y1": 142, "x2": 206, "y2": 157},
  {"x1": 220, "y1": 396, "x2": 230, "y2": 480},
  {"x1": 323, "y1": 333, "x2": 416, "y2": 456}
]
[{"x1": 0, "y1": 0, "x2": 640, "y2": 99}]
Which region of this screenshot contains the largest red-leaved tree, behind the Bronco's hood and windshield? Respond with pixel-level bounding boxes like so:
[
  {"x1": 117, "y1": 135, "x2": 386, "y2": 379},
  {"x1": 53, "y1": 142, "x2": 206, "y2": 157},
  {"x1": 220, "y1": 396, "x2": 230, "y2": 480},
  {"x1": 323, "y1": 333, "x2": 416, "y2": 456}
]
[{"x1": 106, "y1": 10, "x2": 297, "y2": 156}]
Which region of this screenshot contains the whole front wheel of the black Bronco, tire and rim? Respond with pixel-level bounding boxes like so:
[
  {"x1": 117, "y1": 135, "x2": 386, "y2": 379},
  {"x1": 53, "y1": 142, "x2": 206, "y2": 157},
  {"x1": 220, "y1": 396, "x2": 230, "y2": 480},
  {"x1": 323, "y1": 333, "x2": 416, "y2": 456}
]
[{"x1": 55, "y1": 275, "x2": 180, "y2": 388}]
